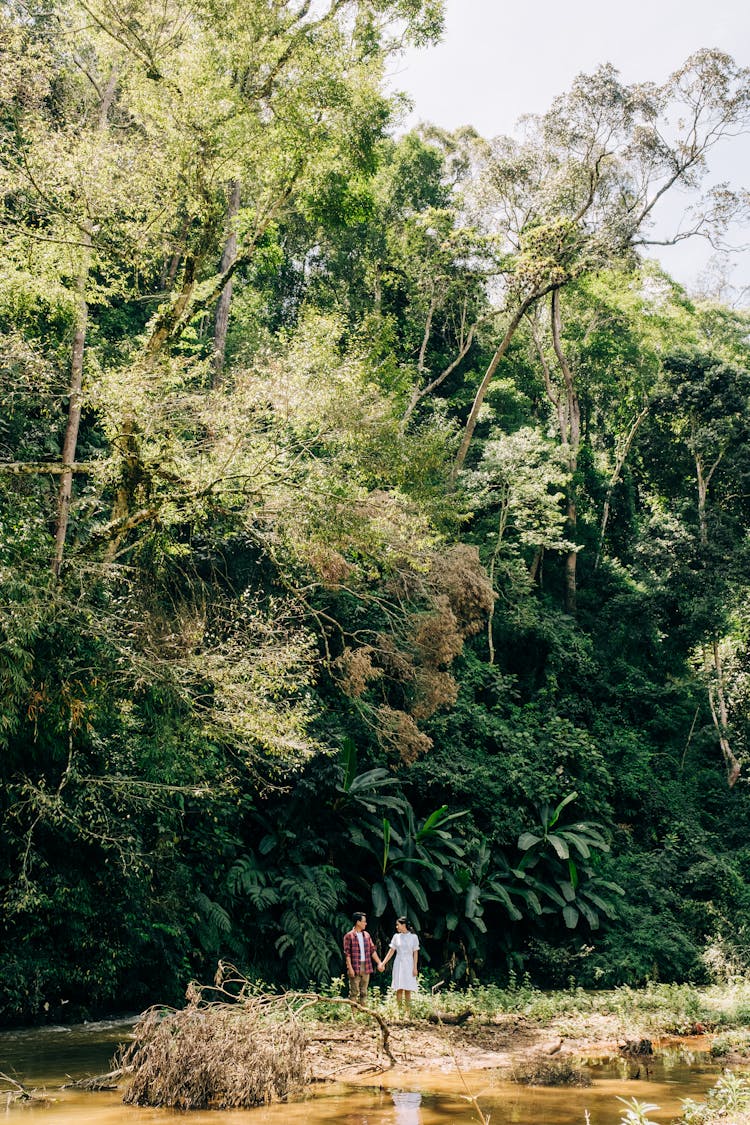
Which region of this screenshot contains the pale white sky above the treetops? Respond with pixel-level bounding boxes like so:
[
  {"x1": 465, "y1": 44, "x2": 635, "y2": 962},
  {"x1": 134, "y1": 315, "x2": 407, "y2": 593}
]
[{"x1": 391, "y1": 0, "x2": 750, "y2": 304}]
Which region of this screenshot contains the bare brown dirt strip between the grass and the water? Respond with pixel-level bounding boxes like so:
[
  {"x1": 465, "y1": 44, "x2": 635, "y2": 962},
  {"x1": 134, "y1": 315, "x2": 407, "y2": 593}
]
[{"x1": 307, "y1": 1016, "x2": 661, "y2": 1082}]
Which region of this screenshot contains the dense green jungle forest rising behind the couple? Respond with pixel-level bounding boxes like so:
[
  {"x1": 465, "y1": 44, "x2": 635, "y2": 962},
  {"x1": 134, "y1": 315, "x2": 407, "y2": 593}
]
[{"x1": 0, "y1": 0, "x2": 750, "y2": 1023}]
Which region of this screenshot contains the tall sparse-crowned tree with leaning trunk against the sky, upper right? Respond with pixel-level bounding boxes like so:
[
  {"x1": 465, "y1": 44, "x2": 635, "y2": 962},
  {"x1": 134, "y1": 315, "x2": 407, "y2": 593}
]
[{"x1": 454, "y1": 51, "x2": 750, "y2": 476}]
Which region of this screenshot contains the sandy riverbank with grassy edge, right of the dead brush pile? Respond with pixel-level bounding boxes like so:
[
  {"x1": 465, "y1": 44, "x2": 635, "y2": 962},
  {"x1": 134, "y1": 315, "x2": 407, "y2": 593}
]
[{"x1": 306, "y1": 979, "x2": 750, "y2": 1082}]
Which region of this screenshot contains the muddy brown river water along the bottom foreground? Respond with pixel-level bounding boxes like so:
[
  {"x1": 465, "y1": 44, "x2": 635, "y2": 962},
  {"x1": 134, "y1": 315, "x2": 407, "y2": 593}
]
[{"x1": 0, "y1": 1020, "x2": 721, "y2": 1125}]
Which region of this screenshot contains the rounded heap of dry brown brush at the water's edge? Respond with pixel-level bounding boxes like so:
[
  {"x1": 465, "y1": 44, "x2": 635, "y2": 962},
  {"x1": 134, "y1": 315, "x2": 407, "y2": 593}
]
[{"x1": 121, "y1": 993, "x2": 306, "y2": 1109}]
